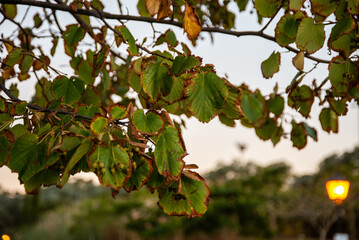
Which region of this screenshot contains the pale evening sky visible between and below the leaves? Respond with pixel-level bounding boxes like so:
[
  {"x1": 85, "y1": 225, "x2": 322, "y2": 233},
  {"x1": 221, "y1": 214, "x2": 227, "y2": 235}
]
[{"x1": 0, "y1": 1, "x2": 359, "y2": 192}]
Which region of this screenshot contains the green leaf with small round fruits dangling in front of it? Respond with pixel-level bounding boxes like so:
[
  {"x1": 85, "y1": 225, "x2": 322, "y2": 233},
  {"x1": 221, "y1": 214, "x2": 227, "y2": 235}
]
[{"x1": 88, "y1": 145, "x2": 131, "y2": 189}]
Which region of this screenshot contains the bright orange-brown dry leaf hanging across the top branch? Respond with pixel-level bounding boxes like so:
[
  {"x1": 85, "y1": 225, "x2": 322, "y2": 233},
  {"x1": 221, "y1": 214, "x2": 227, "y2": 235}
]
[{"x1": 183, "y1": 2, "x2": 202, "y2": 40}]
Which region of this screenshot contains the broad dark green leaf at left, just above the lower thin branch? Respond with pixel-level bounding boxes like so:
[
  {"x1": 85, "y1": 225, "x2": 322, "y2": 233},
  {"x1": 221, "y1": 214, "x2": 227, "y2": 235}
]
[{"x1": 51, "y1": 76, "x2": 84, "y2": 104}]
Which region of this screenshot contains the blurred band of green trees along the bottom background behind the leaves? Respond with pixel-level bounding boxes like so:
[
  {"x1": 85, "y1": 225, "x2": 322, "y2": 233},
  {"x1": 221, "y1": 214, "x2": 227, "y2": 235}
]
[{"x1": 0, "y1": 148, "x2": 359, "y2": 240}]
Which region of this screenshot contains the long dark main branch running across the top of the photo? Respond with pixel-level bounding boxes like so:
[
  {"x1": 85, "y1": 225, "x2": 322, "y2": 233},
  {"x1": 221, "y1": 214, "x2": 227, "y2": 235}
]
[{"x1": 0, "y1": 0, "x2": 330, "y2": 64}]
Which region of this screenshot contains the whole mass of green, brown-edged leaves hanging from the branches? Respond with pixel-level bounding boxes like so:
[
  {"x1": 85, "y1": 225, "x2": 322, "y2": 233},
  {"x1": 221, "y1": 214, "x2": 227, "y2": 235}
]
[{"x1": 0, "y1": 0, "x2": 359, "y2": 217}]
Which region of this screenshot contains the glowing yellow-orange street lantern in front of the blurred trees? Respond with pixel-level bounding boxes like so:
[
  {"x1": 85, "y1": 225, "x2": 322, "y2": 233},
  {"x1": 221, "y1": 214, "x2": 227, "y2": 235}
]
[{"x1": 326, "y1": 180, "x2": 350, "y2": 205}]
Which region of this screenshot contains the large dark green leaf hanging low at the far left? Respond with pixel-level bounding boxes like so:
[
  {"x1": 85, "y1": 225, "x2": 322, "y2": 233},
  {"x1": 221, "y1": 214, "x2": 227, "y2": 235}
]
[{"x1": 8, "y1": 134, "x2": 41, "y2": 182}]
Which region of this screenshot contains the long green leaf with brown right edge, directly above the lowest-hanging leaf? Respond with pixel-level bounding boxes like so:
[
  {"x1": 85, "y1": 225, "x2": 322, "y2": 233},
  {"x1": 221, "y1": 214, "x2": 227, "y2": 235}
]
[{"x1": 155, "y1": 126, "x2": 184, "y2": 177}]
